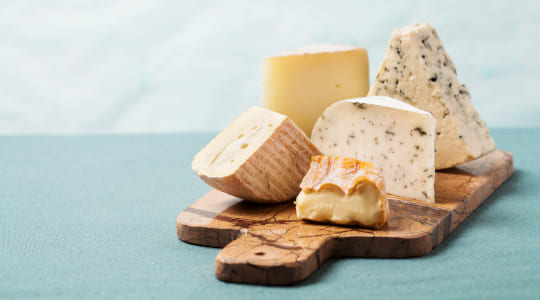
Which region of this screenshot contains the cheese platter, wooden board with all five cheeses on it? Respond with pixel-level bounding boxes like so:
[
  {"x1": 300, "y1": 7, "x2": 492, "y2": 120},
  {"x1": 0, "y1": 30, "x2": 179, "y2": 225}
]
[{"x1": 176, "y1": 24, "x2": 514, "y2": 285}]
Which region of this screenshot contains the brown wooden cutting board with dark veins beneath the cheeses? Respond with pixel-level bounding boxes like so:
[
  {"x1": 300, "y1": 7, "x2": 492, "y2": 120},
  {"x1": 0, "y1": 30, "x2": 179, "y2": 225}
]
[{"x1": 176, "y1": 150, "x2": 514, "y2": 285}]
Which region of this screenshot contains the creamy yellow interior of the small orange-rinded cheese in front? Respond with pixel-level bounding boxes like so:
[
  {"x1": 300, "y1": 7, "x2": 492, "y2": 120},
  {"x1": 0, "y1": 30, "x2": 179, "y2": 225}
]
[{"x1": 296, "y1": 181, "x2": 384, "y2": 227}]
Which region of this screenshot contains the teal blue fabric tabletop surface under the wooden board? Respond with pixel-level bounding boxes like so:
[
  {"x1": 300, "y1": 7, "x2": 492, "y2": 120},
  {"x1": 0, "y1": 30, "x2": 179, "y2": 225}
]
[{"x1": 0, "y1": 129, "x2": 540, "y2": 299}]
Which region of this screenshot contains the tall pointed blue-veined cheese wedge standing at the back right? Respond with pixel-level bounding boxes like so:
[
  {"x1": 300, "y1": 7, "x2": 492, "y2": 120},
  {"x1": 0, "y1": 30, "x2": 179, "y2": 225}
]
[{"x1": 369, "y1": 24, "x2": 495, "y2": 169}]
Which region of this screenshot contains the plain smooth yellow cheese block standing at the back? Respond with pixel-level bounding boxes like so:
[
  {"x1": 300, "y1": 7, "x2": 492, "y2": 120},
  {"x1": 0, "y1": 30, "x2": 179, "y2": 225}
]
[{"x1": 262, "y1": 44, "x2": 369, "y2": 136}]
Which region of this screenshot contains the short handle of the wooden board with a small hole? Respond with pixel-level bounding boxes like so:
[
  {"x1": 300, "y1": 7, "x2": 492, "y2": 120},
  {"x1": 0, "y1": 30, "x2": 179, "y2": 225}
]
[{"x1": 215, "y1": 233, "x2": 334, "y2": 285}]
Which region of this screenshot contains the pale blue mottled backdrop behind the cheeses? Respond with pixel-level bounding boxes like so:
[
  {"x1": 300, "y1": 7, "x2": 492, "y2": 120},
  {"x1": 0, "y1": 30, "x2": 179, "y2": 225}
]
[{"x1": 0, "y1": 0, "x2": 540, "y2": 134}]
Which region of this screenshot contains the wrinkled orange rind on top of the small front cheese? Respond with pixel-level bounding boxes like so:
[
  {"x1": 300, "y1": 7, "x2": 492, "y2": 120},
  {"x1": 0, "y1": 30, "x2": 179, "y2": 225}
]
[{"x1": 300, "y1": 155, "x2": 386, "y2": 198}]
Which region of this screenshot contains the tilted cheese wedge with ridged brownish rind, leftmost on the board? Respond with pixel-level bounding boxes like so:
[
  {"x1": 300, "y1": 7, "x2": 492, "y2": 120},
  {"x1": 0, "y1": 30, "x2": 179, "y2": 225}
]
[{"x1": 192, "y1": 107, "x2": 320, "y2": 203}]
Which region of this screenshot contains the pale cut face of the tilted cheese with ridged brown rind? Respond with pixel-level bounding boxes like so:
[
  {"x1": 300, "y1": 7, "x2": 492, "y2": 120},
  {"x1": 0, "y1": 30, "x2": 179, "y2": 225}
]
[{"x1": 193, "y1": 107, "x2": 286, "y2": 177}]
